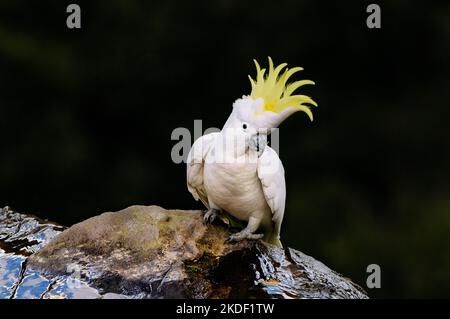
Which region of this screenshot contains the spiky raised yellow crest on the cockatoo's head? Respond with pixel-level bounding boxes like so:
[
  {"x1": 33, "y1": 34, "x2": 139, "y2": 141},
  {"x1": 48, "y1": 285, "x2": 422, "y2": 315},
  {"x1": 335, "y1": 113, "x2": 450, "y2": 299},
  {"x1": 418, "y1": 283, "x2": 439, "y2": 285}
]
[{"x1": 248, "y1": 57, "x2": 317, "y2": 121}]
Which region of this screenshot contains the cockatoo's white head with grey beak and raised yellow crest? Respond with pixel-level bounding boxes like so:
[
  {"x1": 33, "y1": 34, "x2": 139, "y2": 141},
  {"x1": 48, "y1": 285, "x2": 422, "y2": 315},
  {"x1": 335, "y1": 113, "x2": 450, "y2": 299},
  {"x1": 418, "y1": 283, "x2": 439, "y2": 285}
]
[{"x1": 224, "y1": 57, "x2": 317, "y2": 156}]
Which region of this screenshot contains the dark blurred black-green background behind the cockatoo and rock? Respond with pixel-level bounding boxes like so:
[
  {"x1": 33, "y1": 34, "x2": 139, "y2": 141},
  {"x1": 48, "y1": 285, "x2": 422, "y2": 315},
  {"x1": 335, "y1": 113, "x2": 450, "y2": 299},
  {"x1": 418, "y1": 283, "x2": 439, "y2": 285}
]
[{"x1": 0, "y1": 0, "x2": 450, "y2": 297}]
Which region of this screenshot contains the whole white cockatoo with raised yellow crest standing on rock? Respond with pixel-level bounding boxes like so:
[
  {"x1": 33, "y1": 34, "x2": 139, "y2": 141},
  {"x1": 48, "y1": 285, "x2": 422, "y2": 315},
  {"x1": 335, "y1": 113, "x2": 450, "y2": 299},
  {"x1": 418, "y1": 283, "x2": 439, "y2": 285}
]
[{"x1": 187, "y1": 57, "x2": 317, "y2": 247}]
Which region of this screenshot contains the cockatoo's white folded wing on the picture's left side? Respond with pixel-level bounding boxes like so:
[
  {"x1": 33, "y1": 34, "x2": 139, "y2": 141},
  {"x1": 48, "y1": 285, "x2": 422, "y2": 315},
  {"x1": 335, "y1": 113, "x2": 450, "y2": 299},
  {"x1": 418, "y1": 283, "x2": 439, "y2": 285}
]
[{"x1": 186, "y1": 133, "x2": 219, "y2": 208}]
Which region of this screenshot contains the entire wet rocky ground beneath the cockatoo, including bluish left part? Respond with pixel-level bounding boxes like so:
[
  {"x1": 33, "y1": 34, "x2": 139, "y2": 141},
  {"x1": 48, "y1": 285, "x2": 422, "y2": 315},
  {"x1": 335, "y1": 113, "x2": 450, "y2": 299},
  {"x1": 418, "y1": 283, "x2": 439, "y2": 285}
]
[{"x1": 0, "y1": 206, "x2": 367, "y2": 298}]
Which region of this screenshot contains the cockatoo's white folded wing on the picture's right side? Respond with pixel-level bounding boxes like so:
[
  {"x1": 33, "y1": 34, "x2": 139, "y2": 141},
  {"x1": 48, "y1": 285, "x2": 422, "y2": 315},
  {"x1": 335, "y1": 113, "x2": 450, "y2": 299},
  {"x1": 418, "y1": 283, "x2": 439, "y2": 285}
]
[{"x1": 258, "y1": 146, "x2": 286, "y2": 234}]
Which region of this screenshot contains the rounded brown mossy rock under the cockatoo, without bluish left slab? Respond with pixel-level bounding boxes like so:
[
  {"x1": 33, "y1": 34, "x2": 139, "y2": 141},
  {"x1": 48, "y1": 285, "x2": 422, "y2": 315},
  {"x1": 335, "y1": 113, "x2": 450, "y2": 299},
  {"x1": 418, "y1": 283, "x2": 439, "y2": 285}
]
[{"x1": 28, "y1": 206, "x2": 366, "y2": 298}]
